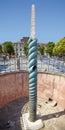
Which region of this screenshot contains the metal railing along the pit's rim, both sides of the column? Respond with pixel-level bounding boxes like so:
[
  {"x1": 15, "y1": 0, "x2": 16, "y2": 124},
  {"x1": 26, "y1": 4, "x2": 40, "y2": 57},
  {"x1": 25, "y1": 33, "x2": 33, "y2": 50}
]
[{"x1": 0, "y1": 56, "x2": 65, "y2": 74}]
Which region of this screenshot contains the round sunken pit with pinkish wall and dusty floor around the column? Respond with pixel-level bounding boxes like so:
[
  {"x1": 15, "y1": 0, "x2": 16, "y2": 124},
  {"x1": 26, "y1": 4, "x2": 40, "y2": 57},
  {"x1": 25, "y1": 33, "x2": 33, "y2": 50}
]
[{"x1": 0, "y1": 71, "x2": 65, "y2": 130}]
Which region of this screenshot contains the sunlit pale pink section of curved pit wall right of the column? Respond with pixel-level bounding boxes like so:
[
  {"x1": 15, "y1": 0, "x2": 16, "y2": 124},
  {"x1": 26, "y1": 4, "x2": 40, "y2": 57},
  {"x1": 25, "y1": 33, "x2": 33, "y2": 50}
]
[{"x1": 38, "y1": 73, "x2": 65, "y2": 109}]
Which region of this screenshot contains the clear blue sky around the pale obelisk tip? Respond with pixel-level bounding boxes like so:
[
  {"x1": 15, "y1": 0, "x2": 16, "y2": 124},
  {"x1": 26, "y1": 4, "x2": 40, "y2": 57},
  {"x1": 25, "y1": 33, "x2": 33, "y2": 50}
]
[{"x1": 0, "y1": 0, "x2": 65, "y2": 43}]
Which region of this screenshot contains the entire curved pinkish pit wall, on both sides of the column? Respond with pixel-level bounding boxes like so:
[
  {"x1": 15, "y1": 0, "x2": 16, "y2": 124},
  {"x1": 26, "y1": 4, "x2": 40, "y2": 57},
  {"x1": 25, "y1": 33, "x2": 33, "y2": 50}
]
[{"x1": 0, "y1": 72, "x2": 65, "y2": 109}]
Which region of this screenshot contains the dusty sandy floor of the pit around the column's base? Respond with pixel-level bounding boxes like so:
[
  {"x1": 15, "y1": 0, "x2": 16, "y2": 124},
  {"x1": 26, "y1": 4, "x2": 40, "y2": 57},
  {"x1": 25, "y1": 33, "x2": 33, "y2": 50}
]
[{"x1": 0, "y1": 97, "x2": 65, "y2": 130}]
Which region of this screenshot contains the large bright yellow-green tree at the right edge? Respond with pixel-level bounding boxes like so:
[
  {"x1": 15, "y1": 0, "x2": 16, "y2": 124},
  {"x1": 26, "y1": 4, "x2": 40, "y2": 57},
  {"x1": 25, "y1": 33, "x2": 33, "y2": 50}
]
[{"x1": 53, "y1": 37, "x2": 65, "y2": 56}]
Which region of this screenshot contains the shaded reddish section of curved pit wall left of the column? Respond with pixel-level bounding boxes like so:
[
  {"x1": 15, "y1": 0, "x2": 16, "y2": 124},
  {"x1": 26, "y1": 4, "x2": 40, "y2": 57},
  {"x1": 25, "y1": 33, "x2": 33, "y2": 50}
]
[{"x1": 0, "y1": 72, "x2": 28, "y2": 107}]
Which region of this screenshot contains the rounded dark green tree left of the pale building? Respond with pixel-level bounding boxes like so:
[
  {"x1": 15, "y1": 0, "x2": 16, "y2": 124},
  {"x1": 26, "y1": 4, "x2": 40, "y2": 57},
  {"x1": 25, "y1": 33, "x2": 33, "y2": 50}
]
[{"x1": 4, "y1": 42, "x2": 14, "y2": 55}]
